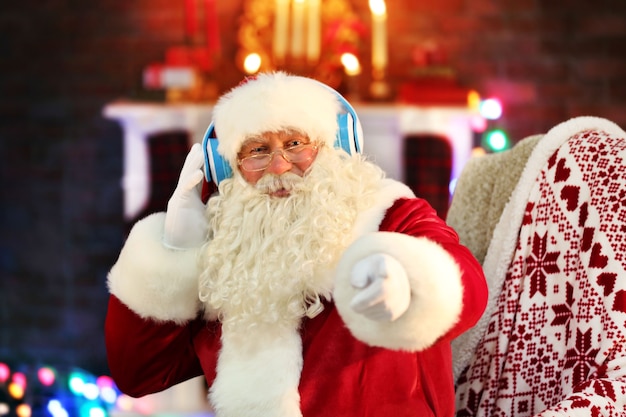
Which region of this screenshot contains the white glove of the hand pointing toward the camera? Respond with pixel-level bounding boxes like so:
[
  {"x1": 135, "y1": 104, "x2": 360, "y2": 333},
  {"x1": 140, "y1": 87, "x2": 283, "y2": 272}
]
[{"x1": 350, "y1": 253, "x2": 411, "y2": 321}]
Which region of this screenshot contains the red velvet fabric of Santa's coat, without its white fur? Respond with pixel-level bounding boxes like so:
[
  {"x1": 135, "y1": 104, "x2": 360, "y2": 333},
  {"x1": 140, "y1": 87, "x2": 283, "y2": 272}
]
[{"x1": 105, "y1": 198, "x2": 487, "y2": 417}]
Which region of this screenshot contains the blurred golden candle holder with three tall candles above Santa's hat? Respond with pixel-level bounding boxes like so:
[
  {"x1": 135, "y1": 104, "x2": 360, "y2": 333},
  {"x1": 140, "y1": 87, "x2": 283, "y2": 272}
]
[{"x1": 236, "y1": 0, "x2": 366, "y2": 76}]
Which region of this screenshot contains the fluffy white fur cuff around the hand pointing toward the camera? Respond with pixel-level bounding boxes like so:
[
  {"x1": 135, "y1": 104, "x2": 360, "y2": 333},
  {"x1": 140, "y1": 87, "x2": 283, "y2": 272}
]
[{"x1": 334, "y1": 232, "x2": 463, "y2": 351}]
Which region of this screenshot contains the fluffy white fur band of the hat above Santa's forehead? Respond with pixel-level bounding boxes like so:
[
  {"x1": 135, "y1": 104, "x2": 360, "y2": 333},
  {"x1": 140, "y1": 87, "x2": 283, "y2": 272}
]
[{"x1": 213, "y1": 72, "x2": 341, "y2": 166}]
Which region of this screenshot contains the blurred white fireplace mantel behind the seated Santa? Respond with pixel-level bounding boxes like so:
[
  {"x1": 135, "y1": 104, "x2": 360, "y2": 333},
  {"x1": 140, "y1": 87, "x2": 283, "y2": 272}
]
[{"x1": 103, "y1": 101, "x2": 478, "y2": 220}]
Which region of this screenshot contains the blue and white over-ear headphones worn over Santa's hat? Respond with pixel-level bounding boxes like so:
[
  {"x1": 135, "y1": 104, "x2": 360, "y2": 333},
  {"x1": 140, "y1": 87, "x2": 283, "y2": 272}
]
[{"x1": 202, "y1": 79, "x2": 363, "y2": 185}]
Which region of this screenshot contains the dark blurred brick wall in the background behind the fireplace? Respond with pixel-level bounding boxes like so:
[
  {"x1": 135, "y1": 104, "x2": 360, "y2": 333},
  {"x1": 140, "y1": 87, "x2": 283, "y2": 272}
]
[{"x1": 0, "y1": 0, "x2": 626, "y2": 373}]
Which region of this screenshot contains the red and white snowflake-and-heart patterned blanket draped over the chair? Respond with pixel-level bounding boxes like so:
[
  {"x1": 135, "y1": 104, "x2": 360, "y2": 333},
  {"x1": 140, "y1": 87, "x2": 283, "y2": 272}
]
[{"x1": 457, "y1": 130, "x2": 626, "y2": 417}]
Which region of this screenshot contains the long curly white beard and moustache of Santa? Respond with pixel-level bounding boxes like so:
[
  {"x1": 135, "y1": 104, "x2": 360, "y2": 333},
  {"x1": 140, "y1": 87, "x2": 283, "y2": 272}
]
[{"x1": 200, "y1": 148, "x2": 383, "y2": 325}]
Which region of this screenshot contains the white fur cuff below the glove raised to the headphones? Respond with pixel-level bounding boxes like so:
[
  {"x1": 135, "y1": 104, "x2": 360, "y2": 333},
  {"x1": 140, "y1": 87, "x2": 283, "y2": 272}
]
[{"x1": 108, "y1": 213, "x2": 200, "y2": 323}]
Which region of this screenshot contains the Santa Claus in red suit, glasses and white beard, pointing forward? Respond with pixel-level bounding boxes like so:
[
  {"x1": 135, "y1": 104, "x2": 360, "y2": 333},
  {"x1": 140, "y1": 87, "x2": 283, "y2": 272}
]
[{"x1": 106, "y1": 72, "x2": 487, "y2": 417}]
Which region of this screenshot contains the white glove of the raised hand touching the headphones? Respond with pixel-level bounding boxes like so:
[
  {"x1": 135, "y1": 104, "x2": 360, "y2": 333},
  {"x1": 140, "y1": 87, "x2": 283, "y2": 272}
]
[{"x1": 163, "y1": 143, "x2": 208, "y2": 249}]
